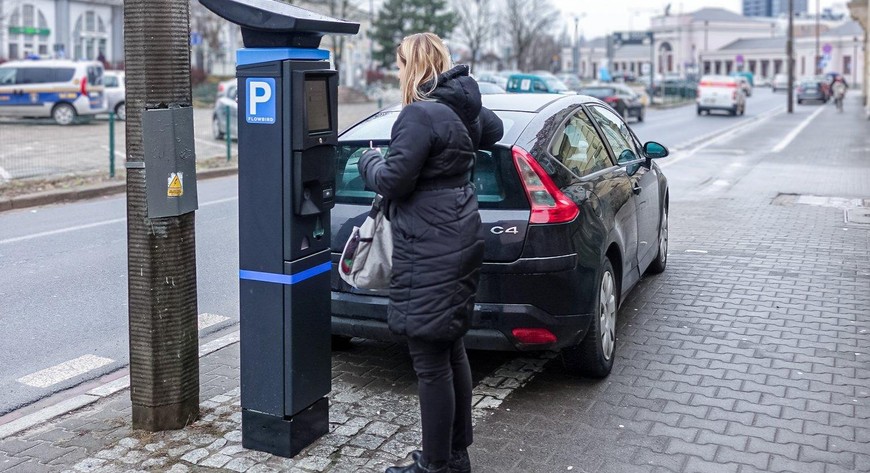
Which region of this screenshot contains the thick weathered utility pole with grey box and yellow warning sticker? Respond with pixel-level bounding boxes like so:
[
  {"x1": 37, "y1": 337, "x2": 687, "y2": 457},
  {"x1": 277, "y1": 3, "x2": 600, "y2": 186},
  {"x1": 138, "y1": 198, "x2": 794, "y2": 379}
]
[{"x1": 124, "y1": 0, "x2": 199, "y2": 431}]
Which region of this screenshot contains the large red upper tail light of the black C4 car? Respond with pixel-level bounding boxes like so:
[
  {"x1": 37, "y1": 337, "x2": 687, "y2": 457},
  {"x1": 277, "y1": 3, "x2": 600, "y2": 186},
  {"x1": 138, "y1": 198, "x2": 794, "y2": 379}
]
[{"x1": 513, "y1": 146, "x2": 580, "y2": 223}]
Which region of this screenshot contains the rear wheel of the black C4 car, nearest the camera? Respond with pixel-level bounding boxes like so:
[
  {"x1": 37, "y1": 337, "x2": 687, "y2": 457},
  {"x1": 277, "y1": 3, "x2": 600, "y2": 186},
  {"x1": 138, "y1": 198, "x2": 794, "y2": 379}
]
[{"x1": 562, "y1": 258, "x2": 619, "y2": 378}]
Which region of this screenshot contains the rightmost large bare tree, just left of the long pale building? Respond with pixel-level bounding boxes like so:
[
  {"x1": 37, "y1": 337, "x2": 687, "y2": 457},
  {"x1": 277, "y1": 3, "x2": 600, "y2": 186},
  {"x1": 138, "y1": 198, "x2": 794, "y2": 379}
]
[{"x1": 502, "y1": 0, "x2": 559, "y2": 70}]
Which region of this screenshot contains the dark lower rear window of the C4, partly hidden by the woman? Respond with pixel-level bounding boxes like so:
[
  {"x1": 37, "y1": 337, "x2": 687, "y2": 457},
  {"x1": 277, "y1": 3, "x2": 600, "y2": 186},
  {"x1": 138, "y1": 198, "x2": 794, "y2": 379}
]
[{"x1": 335, "y1": 141, "x2": 528, "y2": 209}]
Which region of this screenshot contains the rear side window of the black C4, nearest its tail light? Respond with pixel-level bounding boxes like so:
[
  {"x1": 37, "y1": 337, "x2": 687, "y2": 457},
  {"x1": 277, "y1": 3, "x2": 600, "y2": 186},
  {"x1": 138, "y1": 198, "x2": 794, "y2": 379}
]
[{"x1": 550, "y1": 110, "x2": 613, "y2": 176}]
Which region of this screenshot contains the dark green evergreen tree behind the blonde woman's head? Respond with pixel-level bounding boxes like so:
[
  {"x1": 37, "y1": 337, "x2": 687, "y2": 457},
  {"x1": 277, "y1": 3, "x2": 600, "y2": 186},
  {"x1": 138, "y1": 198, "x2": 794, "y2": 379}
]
[{"x1": 372, "y1": 0, "x2": 457, "y2": 66}]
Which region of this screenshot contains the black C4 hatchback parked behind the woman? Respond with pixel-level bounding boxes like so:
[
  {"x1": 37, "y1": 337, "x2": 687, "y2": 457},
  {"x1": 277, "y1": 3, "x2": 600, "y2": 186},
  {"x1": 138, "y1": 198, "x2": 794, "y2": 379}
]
[{"x1": 331, "y1": 94, "x2": 668, "y2": 376}]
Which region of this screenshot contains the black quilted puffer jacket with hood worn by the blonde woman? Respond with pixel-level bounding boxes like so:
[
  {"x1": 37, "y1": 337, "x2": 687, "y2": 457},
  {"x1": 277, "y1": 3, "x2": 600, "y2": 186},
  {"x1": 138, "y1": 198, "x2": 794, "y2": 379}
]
[{"x1": 359, "y1": 66, "x2": 504, "y2": 340}]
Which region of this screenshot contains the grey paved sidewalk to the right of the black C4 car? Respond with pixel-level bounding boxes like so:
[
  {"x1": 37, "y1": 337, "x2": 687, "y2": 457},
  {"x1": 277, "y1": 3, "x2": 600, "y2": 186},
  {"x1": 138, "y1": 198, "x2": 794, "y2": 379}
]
[{"x1": 473, "y1": 98, "x2": 870, "y2": 473}]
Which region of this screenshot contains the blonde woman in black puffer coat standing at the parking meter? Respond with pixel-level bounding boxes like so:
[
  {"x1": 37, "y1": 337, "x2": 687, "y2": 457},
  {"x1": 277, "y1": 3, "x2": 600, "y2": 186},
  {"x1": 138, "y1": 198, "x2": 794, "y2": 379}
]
[{"x1": 359, "y1": 33, "x2": 503, "y2": 473}]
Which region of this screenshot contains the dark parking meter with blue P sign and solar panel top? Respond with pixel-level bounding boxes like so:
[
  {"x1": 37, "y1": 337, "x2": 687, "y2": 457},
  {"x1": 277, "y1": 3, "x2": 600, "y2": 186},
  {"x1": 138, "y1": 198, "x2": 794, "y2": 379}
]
[{"x1": 200, "y1": 0, "x2": 359, "y2": 457}]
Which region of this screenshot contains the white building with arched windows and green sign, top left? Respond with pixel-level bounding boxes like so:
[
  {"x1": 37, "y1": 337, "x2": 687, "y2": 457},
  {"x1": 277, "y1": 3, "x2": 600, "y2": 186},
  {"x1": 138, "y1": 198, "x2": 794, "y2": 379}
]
[{"x1": 0, "y1": 0, "x2": 124, "y2": 64}]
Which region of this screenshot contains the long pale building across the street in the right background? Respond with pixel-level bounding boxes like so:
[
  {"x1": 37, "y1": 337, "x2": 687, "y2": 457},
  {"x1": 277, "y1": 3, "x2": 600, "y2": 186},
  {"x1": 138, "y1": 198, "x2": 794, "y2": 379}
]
[{"x1": 562, "y1": 8, "x2": 865, "y2": 83}]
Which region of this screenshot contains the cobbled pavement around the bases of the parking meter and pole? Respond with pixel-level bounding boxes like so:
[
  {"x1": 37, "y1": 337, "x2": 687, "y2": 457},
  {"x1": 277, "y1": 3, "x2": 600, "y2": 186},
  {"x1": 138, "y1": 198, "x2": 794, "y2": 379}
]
[{"x1": 0, "y1": 334, "x2": 551, "y2": 473}]
